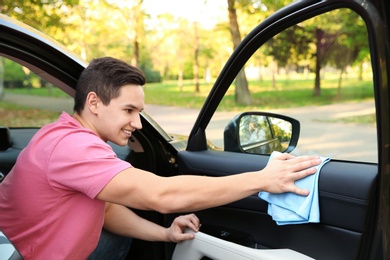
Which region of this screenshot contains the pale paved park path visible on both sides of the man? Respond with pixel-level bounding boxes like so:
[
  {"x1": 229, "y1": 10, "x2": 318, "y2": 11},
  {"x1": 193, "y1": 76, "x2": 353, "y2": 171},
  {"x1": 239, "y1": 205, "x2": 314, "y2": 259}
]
[{"x1": 4, "y1": 93, "x2": 377, "y2": 162}]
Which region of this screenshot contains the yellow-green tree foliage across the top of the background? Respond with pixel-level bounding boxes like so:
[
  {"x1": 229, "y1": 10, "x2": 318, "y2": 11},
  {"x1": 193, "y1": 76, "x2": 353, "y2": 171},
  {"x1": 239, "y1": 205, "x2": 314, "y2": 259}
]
[{"x1": 0, "y1": 0, "x2": 369, "y2": 101}]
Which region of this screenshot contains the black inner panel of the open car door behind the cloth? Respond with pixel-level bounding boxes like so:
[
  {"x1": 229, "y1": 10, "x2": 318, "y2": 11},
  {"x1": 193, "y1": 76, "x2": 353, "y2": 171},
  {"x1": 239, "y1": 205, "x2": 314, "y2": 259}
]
[{"x1": 178, "y1": 151, "x2": 378, "y2": 259}]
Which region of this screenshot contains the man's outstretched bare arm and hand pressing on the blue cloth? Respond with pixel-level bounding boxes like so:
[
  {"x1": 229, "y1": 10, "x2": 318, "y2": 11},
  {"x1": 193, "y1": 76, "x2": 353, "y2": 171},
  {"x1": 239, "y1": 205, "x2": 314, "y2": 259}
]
[{"x1": 97, "y1": 154, "x2": 321, "y2": 213}]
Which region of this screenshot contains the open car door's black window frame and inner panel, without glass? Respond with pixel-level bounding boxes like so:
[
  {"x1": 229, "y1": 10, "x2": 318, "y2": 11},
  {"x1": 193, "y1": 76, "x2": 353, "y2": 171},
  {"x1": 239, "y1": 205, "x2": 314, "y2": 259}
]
[{"x1": 178, "y1": 1, "x2": 389, "y2": 259}]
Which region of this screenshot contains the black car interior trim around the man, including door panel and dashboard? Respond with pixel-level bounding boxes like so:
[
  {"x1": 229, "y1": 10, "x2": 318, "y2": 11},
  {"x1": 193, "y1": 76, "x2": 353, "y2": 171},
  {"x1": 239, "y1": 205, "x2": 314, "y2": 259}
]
[{"x1": 0, "y1": 122, "x2": 378, "y2": 259}]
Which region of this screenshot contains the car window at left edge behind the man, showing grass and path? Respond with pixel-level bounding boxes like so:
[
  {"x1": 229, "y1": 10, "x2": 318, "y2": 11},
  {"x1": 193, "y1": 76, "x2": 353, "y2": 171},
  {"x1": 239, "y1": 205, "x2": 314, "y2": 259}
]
[{"x1": 0, "y1": 56, "x2": 73, "y2": 128}]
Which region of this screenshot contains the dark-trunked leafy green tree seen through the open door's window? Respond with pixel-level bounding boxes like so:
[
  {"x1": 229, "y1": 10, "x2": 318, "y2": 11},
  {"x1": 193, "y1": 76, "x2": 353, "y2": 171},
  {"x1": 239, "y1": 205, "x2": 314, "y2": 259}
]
[{"x1": 265, "y1": 9, "x2": 369, "y2": 96}]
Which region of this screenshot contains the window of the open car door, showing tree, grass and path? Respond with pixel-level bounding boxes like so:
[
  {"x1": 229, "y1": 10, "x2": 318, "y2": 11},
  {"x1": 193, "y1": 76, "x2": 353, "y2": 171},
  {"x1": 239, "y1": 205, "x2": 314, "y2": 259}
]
[{"x1": 206, "y1": 9, "x2": 377, "y2": 162}]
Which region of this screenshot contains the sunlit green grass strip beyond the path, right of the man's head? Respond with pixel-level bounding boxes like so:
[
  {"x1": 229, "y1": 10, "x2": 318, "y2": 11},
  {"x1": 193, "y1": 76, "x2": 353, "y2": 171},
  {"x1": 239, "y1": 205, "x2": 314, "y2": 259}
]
[{"x1": 145, "y1": 79, "x2": 373, "y2": 111}]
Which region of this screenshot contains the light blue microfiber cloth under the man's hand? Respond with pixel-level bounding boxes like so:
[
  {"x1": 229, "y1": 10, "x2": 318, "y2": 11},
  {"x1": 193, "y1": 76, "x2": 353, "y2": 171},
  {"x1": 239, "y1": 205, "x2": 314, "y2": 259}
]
[{"x1": 258, "y1": 152, "x2": 330, "y2": 225}]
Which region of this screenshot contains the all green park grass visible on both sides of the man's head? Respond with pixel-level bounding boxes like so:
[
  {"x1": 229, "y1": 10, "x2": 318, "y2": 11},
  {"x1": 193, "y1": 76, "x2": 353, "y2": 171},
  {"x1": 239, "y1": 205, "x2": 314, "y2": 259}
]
[{"x1": 0, "y1": 78, "x2": 375, "y2": 126}]
